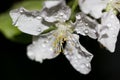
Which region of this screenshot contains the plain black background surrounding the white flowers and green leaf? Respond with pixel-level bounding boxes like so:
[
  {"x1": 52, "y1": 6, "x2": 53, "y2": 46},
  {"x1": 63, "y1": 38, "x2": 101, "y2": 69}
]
[{"x1": 0, "y1": 0, "x2": 120, "y2": 80}]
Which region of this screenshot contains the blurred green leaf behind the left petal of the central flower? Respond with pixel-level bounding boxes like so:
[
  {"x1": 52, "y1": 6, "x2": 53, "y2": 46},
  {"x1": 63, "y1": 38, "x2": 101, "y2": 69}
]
[{"x1": 0, "y1": 0, "x2": 44, "y2": 44}]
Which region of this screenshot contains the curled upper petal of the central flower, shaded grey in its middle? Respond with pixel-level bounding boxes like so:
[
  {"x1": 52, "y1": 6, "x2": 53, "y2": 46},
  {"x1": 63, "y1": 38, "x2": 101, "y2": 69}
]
[{"x1": 42, "y1": 0, "x2": 71, "y2": 22}]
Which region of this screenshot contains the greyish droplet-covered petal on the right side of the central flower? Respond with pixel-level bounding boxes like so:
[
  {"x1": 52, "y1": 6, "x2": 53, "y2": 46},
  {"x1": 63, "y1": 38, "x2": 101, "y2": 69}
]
[{"x1": 74, "y1": 13, "x2": 98, "y2": 39}]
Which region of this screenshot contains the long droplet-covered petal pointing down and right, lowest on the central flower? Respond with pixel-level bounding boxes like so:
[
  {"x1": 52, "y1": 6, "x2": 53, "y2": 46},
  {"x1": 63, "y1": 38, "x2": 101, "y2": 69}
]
[{"x1": 64, "y1": 34, "x2": 93, "y2": 74}]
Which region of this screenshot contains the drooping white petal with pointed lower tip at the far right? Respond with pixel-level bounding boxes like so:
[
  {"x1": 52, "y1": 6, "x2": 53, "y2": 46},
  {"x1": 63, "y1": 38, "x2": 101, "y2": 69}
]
[{"x1": 98, "y1": 11, "x2": 120, "y2": 52}]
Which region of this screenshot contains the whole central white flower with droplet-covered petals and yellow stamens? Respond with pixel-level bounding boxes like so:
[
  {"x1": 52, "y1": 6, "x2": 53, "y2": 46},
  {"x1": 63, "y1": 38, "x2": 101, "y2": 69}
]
[{"x1": 10, "y1": 0, "x2": 97, "y2": 74}]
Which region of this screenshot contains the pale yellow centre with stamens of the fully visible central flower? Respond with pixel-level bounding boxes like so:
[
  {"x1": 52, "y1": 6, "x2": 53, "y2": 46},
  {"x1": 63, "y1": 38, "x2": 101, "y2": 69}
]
[{"x1": 53, "y1": 23, "x2": 72, "y2": 53}]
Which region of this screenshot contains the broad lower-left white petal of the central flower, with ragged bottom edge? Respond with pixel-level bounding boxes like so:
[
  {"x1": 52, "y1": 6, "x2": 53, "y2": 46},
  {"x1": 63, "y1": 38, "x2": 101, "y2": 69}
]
[{"x1": 27, "y1": 33, "x2": 58, "y2": 63}]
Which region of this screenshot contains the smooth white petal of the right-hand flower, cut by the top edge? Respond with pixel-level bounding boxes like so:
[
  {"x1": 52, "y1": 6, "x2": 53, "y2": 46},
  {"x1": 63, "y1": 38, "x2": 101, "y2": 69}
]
[{"x1": 79, "y1": 0, "x2": 109, "y2": 18}]
